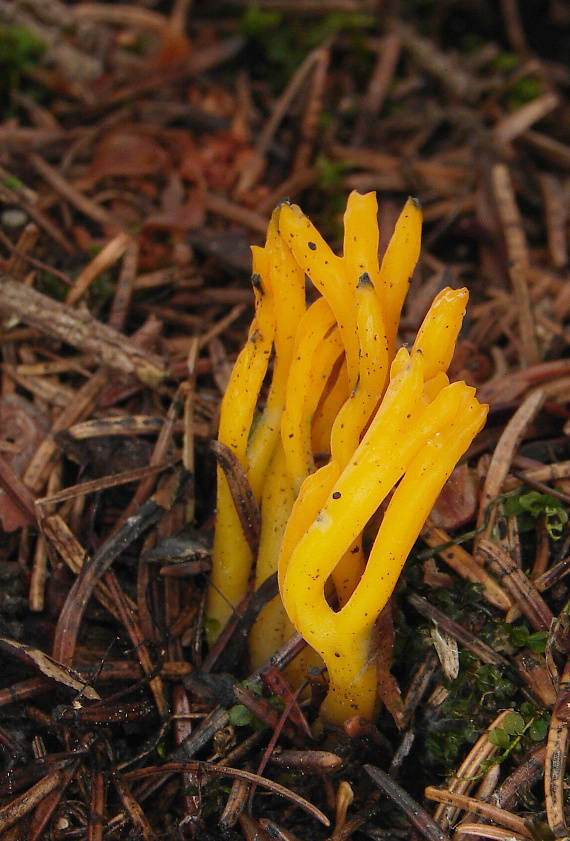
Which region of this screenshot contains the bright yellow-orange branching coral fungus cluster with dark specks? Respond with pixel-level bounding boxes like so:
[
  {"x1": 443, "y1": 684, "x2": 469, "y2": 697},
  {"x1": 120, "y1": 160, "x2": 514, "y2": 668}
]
[{"x1": 208, "y1": 193, "x2": 487, "y2": 723}]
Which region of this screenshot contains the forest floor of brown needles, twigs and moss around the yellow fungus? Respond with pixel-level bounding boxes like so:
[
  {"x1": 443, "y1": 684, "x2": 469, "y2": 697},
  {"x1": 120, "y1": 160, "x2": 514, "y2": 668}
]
[{"x1": 0, "y1": 0, "x2": 570, "y2": 841}]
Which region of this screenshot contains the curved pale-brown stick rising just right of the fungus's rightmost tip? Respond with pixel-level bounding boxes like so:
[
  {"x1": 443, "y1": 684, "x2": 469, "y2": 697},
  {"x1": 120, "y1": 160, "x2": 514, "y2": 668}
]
[{"x1": 473, "y1": 389, "x2": 544, "y2": 561}]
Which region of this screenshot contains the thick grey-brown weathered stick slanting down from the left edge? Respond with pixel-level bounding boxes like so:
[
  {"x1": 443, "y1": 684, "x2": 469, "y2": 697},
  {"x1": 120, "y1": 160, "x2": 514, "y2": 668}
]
[{"x1": 0, "y1": 275, "x2": 166, "y2": 387}]
